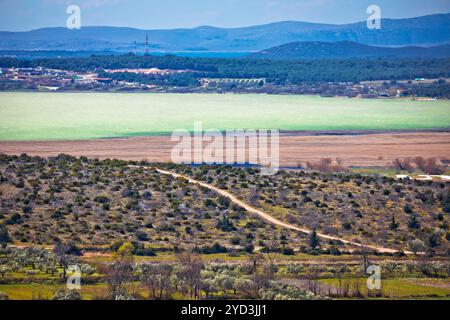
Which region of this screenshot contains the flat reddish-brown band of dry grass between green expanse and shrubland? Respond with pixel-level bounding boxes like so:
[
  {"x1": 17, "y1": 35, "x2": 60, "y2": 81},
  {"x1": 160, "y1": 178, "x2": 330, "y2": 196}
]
[{"x1": 0, "y1": 132, "x2": 450, "y2": 167}]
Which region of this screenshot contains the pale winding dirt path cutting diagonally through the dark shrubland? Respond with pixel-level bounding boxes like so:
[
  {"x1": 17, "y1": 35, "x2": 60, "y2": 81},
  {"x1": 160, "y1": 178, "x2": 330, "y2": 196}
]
[{"x1": 154, "y1": 168, "x2": 412, "y2": 254}]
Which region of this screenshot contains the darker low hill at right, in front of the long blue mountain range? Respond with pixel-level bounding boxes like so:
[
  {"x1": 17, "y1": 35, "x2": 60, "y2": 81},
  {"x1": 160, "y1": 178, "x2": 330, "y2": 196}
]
[{"x1": 248, "y1": 41, "x2": 450, "y2": 60}]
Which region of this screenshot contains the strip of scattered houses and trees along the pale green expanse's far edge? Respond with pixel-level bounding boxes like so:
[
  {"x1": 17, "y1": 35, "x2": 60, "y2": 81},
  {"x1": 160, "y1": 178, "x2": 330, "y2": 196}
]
[{"x1": 0, "y1": 67, "x2": 450, "y2": 100}]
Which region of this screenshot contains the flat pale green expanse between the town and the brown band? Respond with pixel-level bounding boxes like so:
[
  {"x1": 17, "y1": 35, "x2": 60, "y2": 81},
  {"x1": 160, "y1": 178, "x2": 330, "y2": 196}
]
[{"x1": 0, "y1": 92, "x2": 450, "y2": 140}]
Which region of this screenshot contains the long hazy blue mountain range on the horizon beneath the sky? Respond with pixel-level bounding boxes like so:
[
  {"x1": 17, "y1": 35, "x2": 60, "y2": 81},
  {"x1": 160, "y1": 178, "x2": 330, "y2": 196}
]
[{"x1": 0, "y1": 14, "x2": 450, "y2": 52}]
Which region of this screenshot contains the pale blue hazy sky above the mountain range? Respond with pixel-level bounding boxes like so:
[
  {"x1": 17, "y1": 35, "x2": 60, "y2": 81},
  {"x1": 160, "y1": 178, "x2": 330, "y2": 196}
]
[{"x1": 0, "y1": 0, "x2": 450, "y2": 31}]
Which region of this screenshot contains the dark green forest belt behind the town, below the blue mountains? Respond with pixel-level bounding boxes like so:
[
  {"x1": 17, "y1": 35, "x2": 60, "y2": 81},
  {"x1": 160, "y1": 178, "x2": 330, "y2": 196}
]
[{"x1": 0, "y1": 54, "x2": 450, "y2": 84}]
